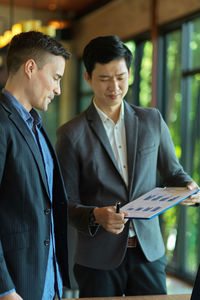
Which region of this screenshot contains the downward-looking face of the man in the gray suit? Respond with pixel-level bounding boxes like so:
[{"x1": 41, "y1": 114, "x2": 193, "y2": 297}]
[{"x1": 85, "y1": 58, "x2": 129, "y2": 110}]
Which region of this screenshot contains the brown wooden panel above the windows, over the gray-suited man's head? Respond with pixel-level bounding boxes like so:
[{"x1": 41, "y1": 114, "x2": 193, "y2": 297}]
[{"x1": 73, "y1": 0, "x2": 200, "y2": 56}]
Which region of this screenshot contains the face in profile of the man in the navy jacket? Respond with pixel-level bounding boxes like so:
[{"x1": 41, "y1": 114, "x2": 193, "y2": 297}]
[{"x1": 29, "y1": 55, "x2": 65, "y2": 111}]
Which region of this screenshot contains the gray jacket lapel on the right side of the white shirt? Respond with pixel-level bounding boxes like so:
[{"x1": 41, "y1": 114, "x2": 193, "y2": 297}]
[{"x1": 124, "y1": 101, "x2": 138, "y2": 191}]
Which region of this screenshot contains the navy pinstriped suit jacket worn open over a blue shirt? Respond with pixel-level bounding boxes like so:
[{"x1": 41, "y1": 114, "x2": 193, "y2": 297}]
[{"x1": 0, "y1": 94, "x2": 69, "y2": 300}]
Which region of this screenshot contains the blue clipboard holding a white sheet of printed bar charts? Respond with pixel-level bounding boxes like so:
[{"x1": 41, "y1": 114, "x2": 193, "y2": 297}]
[{"x1": 120, "y1": 187, "x2": 199, "y2": 219}]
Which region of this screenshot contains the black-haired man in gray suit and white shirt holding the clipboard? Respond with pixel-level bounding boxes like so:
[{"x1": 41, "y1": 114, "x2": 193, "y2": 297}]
[{"x1": 56, "y1": 36, "x2": 197, "y2": 297}]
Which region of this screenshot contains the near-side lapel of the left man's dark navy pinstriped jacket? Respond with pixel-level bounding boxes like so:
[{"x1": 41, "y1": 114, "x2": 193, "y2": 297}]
[{"x1": 1, "y1": 97, "x2": 49, "y2": 196}]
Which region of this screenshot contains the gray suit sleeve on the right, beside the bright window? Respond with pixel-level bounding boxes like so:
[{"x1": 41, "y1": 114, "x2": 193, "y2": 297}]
[{"x1": 158, "y1": 113, "x2": 193, "y2": 186}]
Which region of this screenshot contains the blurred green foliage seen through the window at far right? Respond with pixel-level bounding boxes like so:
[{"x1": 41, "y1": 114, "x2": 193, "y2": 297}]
[{"x1": 162, "y1": 19, "x2": 200, "y2": 276}]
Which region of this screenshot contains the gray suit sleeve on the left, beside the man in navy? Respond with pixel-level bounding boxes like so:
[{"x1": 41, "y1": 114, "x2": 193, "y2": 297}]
[{"x1": 56, "y1": 127, "x2": 98, "y2": 236}]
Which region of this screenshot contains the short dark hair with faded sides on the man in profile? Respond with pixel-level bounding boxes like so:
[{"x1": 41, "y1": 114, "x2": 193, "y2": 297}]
[{"x1": 6, "y1": 31, "x2": 70, "y2": 74}]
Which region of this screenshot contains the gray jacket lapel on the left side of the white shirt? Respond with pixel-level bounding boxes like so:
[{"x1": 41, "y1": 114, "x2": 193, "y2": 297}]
[{"x1": 86, "y1": 104, "x2": 121, "y2": 176}]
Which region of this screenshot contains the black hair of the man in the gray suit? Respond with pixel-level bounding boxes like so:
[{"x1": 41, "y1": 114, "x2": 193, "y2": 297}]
[{"x1": 83, "y1": 35, "x2": 133, "y2": 77}]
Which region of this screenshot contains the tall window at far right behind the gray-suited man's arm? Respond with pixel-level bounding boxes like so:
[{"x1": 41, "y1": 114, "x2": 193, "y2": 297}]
[{"x1": 158, "y1": 18, "x2": 200, "y2": 280}]
